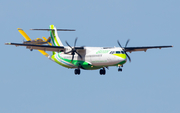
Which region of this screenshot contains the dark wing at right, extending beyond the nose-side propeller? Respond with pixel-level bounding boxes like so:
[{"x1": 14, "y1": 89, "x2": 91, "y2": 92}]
[{"x1": 124, "y1": 46, "x2": 173, "y2": 53}]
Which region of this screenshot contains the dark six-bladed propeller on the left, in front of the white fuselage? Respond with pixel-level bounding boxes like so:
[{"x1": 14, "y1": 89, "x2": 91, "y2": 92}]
[{"x1": 65, "y1": 37, "x2": 82, "y2": 62}]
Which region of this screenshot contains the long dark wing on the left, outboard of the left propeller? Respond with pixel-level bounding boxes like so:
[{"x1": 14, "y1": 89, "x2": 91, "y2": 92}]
[{"x1": 5, "y1": 43, "x2": 65, "y2": 52}]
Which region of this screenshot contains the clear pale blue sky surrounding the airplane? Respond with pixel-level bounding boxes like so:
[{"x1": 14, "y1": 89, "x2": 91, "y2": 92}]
[{"x1": 0, "y1": 0, "x2": 180, "y2": 113}]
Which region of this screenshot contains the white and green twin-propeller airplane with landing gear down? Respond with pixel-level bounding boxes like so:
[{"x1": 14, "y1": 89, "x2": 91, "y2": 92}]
[{"x1": 5, "y1": 25, "x2": 173, "y2": 75}]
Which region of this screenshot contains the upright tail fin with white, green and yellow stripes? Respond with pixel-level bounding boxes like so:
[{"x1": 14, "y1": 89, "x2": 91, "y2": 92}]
[{"x1": 50, "y1": 25, "x2": 63, "y2": 46}]
